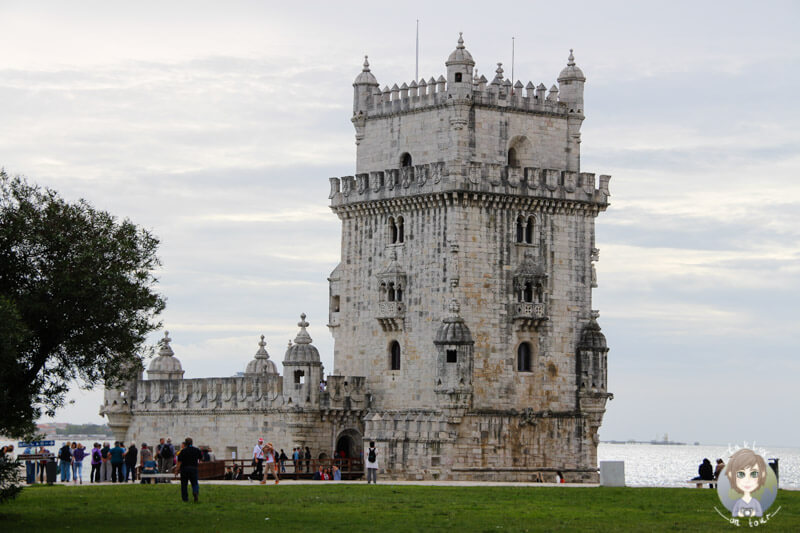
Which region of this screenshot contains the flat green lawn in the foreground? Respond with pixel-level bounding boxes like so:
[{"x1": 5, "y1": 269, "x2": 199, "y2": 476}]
[{"x1": 0, "y1": 483, "x2": 800, "y2": 533}]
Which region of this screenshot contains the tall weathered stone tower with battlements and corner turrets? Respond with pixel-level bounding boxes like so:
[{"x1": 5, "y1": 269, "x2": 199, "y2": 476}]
[{"x1": 326, "y1": 36, "x2": 611, "y2": 481}]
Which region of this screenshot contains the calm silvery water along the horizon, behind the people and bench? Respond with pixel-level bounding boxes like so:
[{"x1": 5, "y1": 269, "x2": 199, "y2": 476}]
[{"x1": 6, "y1": 441, "x2": 800, "y2": 489}]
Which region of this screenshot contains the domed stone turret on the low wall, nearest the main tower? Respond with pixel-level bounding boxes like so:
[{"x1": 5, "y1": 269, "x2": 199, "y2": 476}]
[{"x1": 283, "y1": 313, "x2": 323, "y2": 405}]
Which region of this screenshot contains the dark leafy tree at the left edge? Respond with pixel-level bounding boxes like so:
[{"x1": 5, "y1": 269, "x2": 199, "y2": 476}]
[{"x1": 0, "y1": 170, "x2": 165, "y2": 436}]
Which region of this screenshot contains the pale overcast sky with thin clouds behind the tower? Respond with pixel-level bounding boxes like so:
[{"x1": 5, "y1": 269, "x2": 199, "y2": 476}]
[{"x1": 0, "y1": 0, "x2": 800, "y2": 446}]
